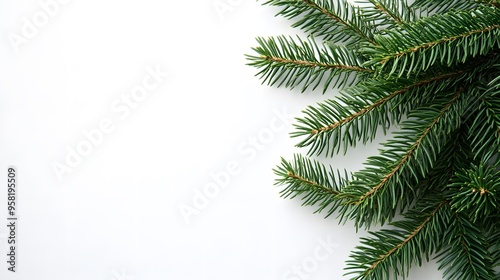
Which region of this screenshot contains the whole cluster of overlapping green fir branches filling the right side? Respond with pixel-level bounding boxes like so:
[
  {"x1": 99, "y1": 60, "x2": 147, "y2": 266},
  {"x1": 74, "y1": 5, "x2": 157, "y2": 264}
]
[{"x1": 248, "y1": 0, "x2": 500, "y2": 280}]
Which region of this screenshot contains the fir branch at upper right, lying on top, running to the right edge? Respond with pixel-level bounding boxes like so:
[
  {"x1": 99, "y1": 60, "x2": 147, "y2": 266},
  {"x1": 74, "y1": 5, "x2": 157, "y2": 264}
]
[{"x1": 365, "y1": 7, "x2": 500, "y2": 77}]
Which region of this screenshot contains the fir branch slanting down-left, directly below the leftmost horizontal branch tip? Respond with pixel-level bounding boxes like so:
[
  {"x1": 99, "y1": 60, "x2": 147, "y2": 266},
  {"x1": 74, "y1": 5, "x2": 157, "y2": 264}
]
[{"x1": 292, "y1": 67, "x2": 464, "y2": 156}]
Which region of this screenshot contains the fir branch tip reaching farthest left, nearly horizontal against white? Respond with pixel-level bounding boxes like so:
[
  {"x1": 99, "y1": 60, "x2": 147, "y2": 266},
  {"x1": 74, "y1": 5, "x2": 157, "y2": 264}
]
[{"x1": 247, "y1": 36, "x2": 374, "y2": 93}]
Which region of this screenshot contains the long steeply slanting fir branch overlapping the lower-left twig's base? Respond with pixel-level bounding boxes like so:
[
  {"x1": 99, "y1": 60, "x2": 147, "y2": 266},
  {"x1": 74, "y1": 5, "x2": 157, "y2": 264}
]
[{"x1": 338, "y1": 89, "x2": 475, "y2": 228}]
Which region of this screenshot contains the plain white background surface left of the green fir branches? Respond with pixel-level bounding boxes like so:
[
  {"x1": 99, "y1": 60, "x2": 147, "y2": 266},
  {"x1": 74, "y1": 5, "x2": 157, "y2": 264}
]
[{"x1": 0, "y1": 0, "x2": 441, "y2": 280}]
